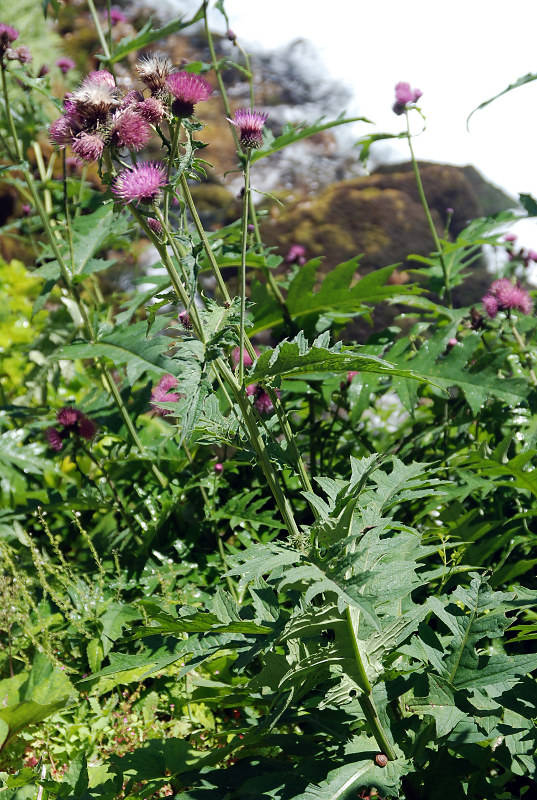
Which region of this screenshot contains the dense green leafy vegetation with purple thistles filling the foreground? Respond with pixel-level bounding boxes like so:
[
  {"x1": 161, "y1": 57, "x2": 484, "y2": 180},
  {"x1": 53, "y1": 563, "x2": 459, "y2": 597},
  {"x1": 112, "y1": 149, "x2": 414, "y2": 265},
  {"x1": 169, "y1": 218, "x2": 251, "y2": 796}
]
[{"x1": 0, "y1": 0, "x2": 537, "y2": 800}]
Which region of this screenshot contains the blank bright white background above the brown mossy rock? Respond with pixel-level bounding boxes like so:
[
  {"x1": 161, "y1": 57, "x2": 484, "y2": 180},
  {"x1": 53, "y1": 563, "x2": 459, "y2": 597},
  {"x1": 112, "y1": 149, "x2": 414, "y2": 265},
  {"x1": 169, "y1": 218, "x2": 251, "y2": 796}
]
[{"x1": 168, "y1": 0, "x2": 537, "y2": 246}]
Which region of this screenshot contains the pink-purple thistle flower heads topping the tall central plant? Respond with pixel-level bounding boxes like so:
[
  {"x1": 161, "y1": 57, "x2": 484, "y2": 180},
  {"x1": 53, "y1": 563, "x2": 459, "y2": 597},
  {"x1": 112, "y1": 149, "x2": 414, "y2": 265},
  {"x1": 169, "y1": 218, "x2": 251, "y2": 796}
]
[{"x1": 49, "y1": 55, "x2": 267, "y2": 203}]
